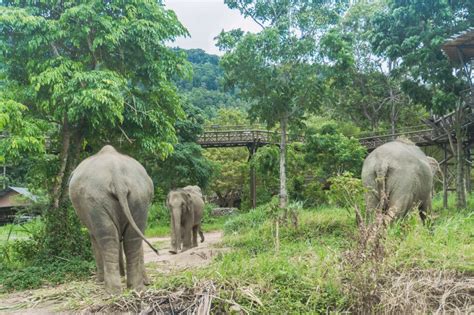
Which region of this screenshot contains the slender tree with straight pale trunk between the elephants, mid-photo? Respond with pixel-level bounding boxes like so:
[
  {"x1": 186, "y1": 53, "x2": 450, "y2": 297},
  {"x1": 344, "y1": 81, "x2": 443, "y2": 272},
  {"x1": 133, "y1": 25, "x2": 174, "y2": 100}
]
[{"x1": 218, "y1": 0, "x2": 339, "y2": 208}]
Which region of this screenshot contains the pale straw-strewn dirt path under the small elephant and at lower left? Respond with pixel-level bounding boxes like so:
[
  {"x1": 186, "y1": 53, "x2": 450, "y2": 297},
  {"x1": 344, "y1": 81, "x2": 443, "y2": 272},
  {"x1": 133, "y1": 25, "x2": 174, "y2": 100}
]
[{"x1": 0, "y1": 232, "x2": 225, "y2": 314}]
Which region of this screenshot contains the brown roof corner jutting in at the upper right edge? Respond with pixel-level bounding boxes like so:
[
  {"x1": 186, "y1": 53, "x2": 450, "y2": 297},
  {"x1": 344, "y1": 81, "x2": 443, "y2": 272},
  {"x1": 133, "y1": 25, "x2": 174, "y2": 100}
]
[{"x1": 441, "y1": 27, "x2": 474, "y2": 64}]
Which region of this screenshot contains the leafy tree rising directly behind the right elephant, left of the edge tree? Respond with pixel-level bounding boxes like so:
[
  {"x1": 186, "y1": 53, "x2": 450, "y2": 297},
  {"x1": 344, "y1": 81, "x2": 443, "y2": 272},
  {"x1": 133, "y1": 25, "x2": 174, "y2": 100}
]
[{"x1": 321, "y1": 1, "x2": 419, "y2": 134}]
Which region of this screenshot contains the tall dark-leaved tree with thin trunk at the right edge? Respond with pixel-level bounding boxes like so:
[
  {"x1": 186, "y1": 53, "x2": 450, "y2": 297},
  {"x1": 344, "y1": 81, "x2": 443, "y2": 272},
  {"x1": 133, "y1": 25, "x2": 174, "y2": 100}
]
[{"x1": 372, "y1": 0, "x2": 474, "y2": 208}]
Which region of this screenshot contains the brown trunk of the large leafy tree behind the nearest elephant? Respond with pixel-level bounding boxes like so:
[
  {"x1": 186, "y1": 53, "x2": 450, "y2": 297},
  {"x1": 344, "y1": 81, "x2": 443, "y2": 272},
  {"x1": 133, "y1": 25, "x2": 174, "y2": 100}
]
[{"x1": 52, "y1": 114, "x2": 71, "y2": 209}]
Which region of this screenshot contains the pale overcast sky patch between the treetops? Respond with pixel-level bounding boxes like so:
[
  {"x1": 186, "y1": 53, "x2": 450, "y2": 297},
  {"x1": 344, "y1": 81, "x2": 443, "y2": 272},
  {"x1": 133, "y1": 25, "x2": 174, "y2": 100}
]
[{"x1": 165, "y1": 0, "x2": 260, "y2": 55}]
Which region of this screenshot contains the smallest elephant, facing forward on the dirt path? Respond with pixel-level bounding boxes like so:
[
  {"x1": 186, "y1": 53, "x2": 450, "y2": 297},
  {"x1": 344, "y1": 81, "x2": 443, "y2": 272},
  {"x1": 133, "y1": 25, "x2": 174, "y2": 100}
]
[{"x1": 166, "y1": 186, "x2": 204, "y2": 254}]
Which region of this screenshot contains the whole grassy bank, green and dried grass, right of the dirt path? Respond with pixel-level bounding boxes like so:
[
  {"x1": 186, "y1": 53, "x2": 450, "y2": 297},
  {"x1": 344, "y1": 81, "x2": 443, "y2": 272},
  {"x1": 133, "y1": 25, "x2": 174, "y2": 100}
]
[{"x1": 134, "y1": 201, "x2": 474, "y2": 313}]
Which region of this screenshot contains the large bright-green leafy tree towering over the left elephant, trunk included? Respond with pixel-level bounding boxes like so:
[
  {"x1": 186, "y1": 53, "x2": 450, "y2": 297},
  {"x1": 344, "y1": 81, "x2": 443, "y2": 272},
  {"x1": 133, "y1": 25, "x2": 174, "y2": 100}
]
[{"x1": 0, "y1": 0, "x2": 188, "y2": 256}]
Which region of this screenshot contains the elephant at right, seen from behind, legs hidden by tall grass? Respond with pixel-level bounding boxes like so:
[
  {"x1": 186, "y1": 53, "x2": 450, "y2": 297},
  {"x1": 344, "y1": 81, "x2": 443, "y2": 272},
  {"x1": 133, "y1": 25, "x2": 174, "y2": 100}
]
[{"x1": 362, "y1": 140, "x2": 439, "y2": 223}]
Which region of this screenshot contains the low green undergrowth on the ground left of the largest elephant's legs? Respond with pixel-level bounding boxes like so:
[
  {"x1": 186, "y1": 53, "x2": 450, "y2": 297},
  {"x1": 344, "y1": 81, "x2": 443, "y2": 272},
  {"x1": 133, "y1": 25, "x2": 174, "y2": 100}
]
[{"x1": 0, "y1": 209, "x2": 95, "y2": 292}]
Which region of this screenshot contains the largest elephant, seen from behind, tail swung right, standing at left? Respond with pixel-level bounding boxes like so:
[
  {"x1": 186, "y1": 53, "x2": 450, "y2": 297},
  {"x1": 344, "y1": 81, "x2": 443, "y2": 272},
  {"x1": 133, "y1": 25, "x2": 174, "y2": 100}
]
[{"x1": 69, "y1": 145, "x2": 153, "y2": 293}]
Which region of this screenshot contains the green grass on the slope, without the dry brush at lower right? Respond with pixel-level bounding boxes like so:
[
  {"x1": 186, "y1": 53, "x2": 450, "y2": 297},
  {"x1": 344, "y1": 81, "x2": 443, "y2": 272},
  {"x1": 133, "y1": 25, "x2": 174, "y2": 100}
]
[{"x1": 143, "y1": 200, "x2": 474, "y2": 314}]
